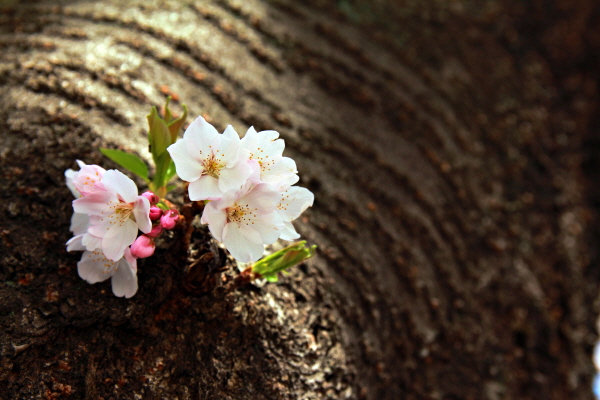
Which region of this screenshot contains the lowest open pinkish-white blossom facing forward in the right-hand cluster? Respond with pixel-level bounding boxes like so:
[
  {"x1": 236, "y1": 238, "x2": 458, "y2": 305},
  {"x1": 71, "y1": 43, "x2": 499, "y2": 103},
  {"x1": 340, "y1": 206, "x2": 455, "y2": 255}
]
[{"x1": 201, "y1": 182, "x2": 284, "y2": 262}]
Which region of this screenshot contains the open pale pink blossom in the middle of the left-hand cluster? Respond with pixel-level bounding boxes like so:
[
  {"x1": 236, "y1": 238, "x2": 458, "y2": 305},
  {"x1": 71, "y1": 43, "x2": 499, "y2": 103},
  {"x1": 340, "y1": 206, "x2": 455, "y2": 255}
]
[{"x1": 73, "y1": 170, "x2": 152, "y2": 261}]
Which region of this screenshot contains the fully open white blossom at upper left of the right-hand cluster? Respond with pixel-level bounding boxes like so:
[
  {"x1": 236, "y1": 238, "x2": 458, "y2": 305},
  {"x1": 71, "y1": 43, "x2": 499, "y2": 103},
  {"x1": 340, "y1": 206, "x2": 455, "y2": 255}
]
[{"x1": 167, "y1": 117, "x2": 251, "y2": 201}]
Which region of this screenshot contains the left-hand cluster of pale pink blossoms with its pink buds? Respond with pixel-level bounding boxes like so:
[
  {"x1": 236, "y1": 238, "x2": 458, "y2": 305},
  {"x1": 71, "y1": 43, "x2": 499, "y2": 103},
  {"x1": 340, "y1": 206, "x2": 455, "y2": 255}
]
[{"x1": 65, "y1": 161, "x2": 177, "y2": 298}]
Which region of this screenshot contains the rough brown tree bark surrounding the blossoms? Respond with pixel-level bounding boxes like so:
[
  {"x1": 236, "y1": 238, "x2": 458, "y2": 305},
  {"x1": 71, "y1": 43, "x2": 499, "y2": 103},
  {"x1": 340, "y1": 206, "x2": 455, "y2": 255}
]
[{"x1": 0, "y1": 0, "x2": 600, "y2": 400}]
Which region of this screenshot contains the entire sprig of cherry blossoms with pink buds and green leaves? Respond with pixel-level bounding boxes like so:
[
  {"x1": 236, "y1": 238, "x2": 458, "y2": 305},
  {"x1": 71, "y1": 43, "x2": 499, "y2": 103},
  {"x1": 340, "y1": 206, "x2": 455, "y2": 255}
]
[{"x1": 65, "y1": 104, "x2": 316, "y2": 298}]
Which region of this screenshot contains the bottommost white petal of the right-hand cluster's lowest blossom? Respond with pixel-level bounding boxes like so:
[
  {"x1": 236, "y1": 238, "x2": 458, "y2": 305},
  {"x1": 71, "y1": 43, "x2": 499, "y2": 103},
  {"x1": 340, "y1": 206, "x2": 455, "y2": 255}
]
[{"x1": 223, "y1": 223, "x2": 265, "y2": 262}]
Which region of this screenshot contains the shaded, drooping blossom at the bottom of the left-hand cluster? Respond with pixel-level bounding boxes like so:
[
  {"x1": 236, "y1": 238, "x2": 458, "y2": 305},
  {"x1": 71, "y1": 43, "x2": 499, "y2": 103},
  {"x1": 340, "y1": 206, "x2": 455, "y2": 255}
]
[{"x1": 77, "y1": 248, "x2": 138, "y2": 298}]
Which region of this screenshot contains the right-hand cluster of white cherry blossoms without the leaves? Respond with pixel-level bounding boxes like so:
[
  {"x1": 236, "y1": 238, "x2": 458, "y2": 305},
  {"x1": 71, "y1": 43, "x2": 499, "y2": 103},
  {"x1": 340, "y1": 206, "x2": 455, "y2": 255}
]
[{"x1": 167, "y1": 117, "x2": 314, "y2": 262}]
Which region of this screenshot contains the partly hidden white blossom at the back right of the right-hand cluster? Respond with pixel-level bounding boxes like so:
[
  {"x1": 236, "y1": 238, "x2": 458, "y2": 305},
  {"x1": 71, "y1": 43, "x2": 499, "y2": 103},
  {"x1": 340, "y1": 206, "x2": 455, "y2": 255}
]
[{"x1": 242, "y1": 127, "x2": 298, "y2": 190}]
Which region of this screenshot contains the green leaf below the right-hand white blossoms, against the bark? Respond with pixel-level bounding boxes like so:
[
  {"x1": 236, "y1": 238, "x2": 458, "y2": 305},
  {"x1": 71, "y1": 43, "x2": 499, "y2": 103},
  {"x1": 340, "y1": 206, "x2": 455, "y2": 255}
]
[{"x1": 252, "y1": 240, "x2": 317, "y2": 282}]
